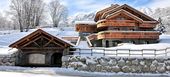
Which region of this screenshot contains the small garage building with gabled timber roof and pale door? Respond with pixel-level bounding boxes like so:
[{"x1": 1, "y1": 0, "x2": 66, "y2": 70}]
[{"x1": 9, "y1": 29, "x2": 74, "y2": 67}]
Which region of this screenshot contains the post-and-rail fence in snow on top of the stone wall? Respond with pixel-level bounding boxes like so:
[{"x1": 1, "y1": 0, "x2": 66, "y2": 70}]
[{"x1": 73, "y1": 47, "x2": 170, "y2": 57}]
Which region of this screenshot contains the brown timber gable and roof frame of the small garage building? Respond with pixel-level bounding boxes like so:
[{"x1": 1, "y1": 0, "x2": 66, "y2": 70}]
[{"x1": 9, "y1": 29, "x2": 73, "y2": 49}]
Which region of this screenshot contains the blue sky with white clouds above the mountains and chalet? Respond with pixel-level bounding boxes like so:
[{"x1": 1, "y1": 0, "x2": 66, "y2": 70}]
[{"x1": 0, "y1": 0, "x2": 170, "y2": 16}]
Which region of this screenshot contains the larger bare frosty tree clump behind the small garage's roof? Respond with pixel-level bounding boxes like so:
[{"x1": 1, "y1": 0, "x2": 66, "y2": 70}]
[{"x1": 10, "y1": 0, "x2": 44, "y2": 32}]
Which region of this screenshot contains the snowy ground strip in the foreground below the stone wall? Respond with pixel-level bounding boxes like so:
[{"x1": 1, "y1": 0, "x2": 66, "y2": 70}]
[{"x1": 0, "y1": 66, "x2": 170, "y2": 77}]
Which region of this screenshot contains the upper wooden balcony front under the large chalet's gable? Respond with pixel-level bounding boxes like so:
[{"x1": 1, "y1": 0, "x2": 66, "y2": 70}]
[{"x1": 97, "y1": 20, "x2": 135, "y2": 28}]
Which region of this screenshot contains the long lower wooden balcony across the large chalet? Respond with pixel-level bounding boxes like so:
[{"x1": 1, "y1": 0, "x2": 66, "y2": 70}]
[{"x1": 97, "y1": 31, "x2": 159, "y2": 39}]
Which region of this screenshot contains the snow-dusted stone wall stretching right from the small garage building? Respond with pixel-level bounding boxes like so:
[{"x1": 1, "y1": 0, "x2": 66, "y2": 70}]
[{"x1": 62, "y1": 56, "x2": 170, "y2": 73}]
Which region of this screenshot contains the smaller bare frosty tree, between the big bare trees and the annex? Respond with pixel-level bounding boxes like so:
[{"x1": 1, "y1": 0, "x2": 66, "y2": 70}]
[{"x1": 49, "y1": 0, "x2": 68, "y2": 27}]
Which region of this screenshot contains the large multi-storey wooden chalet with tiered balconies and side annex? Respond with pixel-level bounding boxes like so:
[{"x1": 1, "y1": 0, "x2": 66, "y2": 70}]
[{"x1": 76, "y1": 4, "x2": 160, "y2": 47}]
